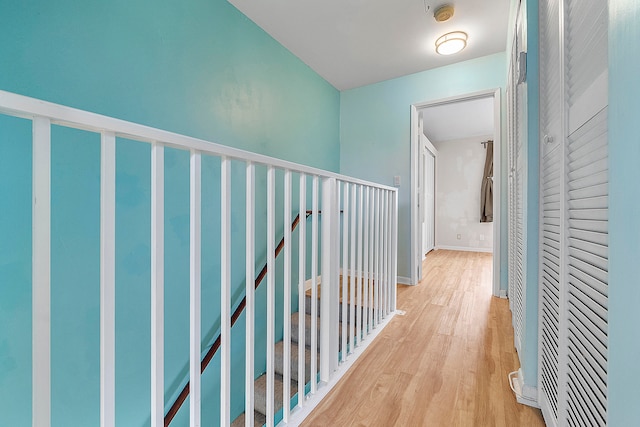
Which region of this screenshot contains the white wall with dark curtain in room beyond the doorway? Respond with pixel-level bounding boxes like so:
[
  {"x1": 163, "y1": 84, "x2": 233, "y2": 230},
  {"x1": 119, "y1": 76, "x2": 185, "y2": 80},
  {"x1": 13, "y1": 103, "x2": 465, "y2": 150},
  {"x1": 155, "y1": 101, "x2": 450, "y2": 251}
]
[{"x1": 433, "y1": 135, "x2": 493, "y2": 252}]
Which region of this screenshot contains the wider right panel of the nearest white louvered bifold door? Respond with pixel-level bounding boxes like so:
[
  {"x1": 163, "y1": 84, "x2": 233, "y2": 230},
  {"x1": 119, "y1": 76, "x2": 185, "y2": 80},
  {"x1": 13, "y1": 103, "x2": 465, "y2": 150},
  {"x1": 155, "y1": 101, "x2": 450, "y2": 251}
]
[{"x1": 564, "y1": 0, "x2": 609, "y2": 426}]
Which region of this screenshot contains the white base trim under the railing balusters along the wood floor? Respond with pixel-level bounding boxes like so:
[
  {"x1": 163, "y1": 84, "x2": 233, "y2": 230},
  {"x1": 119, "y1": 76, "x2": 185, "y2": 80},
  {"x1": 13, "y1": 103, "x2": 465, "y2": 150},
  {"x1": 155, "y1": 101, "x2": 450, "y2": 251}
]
[{"x1": 279, "y1": 312, "x2": 397, "y2": 427}]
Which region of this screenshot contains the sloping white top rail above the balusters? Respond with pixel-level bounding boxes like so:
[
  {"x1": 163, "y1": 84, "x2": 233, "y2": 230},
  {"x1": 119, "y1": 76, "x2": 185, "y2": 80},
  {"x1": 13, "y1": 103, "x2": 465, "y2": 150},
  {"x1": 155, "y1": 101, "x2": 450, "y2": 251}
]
[{"x1": 0, "y1": 90, "x2": 397, "y2": 191}]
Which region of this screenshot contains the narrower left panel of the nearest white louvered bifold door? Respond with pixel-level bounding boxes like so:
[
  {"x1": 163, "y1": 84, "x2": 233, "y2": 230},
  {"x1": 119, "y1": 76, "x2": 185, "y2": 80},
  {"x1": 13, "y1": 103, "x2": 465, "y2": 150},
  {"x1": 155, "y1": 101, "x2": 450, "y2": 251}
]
[{"x1": 538, "y1": 0, "x2": 564, "y2": 425}]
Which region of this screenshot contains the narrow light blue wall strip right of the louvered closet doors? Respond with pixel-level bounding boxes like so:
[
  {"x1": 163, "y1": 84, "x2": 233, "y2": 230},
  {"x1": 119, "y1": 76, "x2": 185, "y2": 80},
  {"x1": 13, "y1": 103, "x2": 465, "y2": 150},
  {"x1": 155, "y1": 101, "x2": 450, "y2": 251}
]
[{"x1": 608, "y1": 0, "x2": 640, "y2": 427}]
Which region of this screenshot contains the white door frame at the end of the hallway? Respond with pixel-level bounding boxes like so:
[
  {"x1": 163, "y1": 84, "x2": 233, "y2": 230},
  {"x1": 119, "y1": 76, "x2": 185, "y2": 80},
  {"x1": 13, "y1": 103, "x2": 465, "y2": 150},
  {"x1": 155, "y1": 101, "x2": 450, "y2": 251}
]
[{"x1": 410, "y1": 88, "x2": 502, "y2": 296}]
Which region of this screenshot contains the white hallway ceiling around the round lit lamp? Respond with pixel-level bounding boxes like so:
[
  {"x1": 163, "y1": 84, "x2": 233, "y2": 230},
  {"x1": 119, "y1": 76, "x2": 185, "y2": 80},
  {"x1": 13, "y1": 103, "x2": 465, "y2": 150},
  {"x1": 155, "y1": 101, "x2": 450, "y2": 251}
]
[{"x1": 229, "y1": 0, "x2": 509, "y2": 90}]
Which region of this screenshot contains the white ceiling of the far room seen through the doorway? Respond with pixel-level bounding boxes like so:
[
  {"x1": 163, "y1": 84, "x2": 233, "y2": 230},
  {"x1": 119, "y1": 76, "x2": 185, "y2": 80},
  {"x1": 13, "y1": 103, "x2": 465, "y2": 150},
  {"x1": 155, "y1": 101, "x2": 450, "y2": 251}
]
[{"x1": 421, "y1": 97, "x2": 494, "y2": 143}]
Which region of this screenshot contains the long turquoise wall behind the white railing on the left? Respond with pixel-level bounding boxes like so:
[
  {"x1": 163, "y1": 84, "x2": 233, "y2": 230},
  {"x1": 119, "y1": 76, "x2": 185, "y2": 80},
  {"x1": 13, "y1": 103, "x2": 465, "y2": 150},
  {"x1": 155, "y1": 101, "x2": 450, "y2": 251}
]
[{"x1": 0, "y1": 0, "x2": 340, "y2": 426}]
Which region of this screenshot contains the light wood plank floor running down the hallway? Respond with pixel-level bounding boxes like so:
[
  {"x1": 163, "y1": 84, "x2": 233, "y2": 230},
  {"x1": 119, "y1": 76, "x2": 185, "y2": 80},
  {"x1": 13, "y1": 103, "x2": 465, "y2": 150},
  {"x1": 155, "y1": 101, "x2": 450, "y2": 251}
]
[{"x1": 302, "y1": 250, "x2": 544, "y2": 427}]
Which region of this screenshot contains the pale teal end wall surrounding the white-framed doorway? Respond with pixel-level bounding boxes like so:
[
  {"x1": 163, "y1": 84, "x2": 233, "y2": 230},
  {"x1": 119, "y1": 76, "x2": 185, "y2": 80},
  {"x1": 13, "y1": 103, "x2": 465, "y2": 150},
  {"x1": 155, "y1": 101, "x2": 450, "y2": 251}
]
[{"x1": 340, "y1": 53, "x2": 507, "y2": 286}]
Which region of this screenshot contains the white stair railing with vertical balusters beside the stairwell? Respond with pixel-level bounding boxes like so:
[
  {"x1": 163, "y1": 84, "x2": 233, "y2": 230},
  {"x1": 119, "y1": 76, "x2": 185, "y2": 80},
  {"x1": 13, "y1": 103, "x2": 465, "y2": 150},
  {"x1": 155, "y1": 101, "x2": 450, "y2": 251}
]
[{"x1": 0, "y1": 91, "x2": 398, "y2": 427}]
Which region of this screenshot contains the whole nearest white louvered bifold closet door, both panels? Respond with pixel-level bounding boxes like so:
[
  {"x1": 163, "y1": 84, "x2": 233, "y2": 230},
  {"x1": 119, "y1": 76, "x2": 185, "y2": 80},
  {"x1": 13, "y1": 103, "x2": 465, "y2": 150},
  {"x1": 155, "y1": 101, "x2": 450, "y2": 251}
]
[{"x1": 539, "y1": 0, "x2": 609, "y2": 426}]
